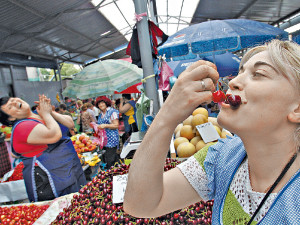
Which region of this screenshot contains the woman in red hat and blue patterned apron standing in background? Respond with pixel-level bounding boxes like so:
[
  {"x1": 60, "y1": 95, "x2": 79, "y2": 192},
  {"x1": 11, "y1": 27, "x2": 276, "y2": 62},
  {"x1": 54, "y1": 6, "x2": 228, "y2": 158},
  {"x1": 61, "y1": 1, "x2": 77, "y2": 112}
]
[{"x1": 96, "y1": 96, "x2": 119, "y2": 168}]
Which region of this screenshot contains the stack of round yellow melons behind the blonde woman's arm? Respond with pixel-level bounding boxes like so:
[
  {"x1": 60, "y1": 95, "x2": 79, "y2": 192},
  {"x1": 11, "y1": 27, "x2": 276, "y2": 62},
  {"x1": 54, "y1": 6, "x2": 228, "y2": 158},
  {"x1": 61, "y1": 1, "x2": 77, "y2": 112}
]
[{"x1": 174, "y1": 107, "x2": 232, "y2": 158}]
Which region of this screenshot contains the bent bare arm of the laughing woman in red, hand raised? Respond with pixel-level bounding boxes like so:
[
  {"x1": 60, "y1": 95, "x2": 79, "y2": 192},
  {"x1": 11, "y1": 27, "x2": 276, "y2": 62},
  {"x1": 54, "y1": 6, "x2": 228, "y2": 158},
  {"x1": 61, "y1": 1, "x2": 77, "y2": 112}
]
[{"x1": 27, "y1": 95, "x2": 62, "y2": 144}]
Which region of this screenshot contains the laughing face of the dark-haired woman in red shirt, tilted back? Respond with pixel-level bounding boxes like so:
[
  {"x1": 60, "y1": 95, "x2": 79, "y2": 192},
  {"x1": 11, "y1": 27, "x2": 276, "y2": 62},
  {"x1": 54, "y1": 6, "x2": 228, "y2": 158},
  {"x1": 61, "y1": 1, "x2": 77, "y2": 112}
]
[{"x1": 1, "y1": 98, "x2": 31, "y2": 119}]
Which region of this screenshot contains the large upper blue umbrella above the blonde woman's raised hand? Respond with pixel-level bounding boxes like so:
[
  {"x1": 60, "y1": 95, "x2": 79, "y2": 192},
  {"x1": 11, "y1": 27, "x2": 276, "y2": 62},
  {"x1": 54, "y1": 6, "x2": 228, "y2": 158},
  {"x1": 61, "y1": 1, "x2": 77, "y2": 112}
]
[{"x1": 158, "y1": 19, "x2": 288, "y2": 59}]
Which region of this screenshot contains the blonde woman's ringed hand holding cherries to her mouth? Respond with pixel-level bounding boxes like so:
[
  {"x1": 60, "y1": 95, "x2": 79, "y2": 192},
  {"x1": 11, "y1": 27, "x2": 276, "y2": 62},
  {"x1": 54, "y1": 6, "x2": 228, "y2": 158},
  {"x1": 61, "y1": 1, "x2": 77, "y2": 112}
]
[{"x1": 160, "y1": 60, "x2": 219, "y2": 124}]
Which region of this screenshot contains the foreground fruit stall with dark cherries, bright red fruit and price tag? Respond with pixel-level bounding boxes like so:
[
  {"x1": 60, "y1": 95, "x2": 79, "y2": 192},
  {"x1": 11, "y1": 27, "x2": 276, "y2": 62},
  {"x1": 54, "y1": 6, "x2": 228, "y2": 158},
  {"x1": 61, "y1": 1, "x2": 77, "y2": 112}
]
[{"x1": 0, "y1": 158, "x2": 213, "y2": 225}]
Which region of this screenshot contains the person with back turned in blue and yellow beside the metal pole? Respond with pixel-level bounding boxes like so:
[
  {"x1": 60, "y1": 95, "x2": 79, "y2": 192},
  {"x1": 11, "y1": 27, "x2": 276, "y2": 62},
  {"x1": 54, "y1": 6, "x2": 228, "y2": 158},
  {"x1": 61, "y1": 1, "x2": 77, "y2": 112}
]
[{"x1": 119, "y1": 94, "x2": 139, "y2": 142}]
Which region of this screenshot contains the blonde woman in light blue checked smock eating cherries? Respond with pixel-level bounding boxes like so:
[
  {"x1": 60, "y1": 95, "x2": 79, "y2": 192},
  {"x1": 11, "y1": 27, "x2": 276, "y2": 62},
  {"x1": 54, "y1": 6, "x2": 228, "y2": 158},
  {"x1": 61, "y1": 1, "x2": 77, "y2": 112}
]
[{"x1": 124, "y1": 40, "x2": 300, "y2": 224}]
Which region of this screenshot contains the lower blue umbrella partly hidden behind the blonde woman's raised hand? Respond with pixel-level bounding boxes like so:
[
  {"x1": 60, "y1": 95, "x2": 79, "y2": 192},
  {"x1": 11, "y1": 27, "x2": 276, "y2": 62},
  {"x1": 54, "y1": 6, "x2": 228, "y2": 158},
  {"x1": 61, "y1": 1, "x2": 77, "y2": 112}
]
[{"x1": 167, "y1": 52, "x2": 241, "y2": 77}]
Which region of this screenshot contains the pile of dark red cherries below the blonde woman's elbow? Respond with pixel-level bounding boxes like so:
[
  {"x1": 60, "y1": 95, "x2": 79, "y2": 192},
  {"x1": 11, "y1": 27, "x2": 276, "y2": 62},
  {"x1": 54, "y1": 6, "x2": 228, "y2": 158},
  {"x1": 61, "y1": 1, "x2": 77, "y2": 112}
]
[{"x1": 51, "y1": 158, "x2": 213, "y2": 225}]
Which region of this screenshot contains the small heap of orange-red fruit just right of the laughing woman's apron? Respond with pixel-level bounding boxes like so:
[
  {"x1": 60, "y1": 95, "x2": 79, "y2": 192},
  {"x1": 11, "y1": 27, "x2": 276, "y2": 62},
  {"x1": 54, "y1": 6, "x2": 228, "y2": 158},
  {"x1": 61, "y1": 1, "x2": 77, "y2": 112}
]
[{"x1": 71, "y1": 133, "x2": 97, "y2": 154}]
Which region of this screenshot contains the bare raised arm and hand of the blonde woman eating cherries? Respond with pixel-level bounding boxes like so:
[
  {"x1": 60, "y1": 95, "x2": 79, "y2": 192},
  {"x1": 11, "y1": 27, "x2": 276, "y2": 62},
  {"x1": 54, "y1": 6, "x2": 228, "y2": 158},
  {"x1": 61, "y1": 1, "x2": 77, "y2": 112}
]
[{"x1": 123, "y1": 61, "x2": 218, "y2": 217}]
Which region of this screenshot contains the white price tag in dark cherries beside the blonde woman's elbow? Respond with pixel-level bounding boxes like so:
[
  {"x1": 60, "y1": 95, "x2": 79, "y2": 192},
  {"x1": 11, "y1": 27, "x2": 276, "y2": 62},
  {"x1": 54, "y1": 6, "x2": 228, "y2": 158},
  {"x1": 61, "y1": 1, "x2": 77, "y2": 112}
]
[{"x1": 112, "y1": 174, "x2": 128, "y2": 204}]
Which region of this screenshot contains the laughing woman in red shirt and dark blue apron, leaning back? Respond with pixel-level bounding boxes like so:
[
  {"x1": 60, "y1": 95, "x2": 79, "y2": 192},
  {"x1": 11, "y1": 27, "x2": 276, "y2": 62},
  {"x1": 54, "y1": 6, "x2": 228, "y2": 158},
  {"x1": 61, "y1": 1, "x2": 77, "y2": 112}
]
[{"x1": 0, "y1": 95, "x2": 86, "y2": 202}]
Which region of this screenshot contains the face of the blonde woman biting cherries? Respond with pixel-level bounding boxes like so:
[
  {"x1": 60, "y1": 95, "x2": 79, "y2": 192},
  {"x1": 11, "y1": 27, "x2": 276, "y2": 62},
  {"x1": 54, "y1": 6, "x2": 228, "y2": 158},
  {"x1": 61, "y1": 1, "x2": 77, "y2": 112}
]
[{"x1": 218, "y1": 51, "x2": 299, "y2": 135}]
